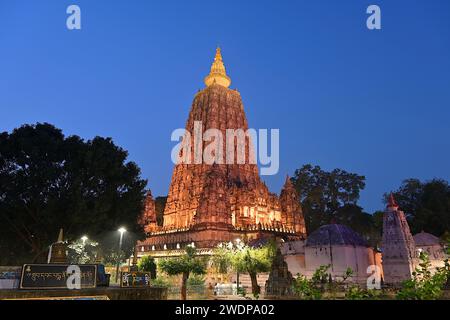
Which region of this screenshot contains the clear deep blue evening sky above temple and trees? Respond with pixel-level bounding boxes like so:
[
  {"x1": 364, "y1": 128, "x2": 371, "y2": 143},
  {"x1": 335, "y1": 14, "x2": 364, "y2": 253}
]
[{"x1": 0, "y1": 0, "x2": 450, "y2": 211}]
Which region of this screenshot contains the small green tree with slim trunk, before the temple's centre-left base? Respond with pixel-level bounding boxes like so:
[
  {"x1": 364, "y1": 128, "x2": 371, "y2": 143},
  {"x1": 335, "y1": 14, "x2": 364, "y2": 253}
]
[{"x1": 159, "y1": 246, "x2": 206, "y2": 300}]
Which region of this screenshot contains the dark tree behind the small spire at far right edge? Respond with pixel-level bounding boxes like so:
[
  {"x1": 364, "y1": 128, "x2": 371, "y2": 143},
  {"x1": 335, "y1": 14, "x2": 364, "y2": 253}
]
[{"x1": 384, "y1": 179, "x2": 450, "y2": 236}]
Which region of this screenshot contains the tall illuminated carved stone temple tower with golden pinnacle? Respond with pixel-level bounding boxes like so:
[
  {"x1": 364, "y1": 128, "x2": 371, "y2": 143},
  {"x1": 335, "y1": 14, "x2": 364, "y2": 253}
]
[{"x1": 137, "y1": 49, "x2": 306, "y2": 256}]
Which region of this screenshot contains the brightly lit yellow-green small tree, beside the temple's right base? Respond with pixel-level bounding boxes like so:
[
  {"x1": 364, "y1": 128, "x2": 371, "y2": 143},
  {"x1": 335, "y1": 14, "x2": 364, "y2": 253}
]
[{"x1": 213, "y1": 243, "x2": 276, "y2": 297}]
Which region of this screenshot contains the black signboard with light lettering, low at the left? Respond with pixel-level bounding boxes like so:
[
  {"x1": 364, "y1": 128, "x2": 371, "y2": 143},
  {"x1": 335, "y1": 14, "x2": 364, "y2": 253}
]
[{"x1": 20, "y1": 264, "x2": 97, "y2": 290}]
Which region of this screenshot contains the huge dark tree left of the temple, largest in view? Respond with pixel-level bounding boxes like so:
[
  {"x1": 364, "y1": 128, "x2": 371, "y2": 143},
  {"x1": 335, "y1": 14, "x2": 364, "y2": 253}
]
[{"x1": 0, "y1": 123, "x2": 146, "y2": 263}]
